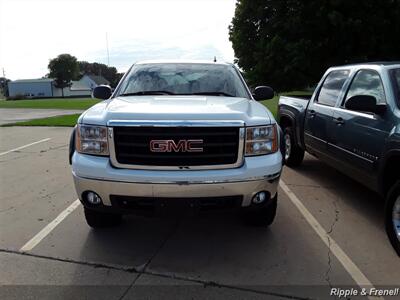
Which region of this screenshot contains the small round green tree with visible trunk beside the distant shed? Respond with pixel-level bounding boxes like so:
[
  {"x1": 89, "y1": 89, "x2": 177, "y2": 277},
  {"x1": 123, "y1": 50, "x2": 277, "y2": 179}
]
[{"x1": 48, "y1": 54, "x2": 79, "y2": 97}]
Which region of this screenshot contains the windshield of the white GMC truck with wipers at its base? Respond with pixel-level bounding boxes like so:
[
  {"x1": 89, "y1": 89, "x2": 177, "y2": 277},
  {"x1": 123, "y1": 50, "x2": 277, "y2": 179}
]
[{"x1": 118, "y1": 63, "x2": 249, "y2": 98}]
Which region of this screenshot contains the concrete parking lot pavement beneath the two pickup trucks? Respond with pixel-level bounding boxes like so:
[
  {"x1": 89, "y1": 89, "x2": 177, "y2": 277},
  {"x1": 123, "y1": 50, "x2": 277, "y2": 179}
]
[{"x1": 0, "y1": 127, "x2": 400, "y2": 299}]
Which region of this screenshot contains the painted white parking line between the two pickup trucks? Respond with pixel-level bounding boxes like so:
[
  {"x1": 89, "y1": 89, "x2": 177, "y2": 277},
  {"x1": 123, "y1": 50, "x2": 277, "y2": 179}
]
[{"x1": 279, "y1": 179, "x2": 383, "y2": 299}]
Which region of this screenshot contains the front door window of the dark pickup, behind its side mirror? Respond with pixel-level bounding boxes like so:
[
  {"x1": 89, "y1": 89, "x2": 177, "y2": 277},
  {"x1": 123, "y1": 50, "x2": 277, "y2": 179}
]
[{"x1": 346, "y1": 70, "x2": 386, "y2": 103}]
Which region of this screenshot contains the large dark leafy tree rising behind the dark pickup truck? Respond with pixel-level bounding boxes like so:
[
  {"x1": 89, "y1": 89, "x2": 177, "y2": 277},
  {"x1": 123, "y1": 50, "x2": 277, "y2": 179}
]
[{"x1": 229, "y1": 0, "x2": 400, "y2": 91}]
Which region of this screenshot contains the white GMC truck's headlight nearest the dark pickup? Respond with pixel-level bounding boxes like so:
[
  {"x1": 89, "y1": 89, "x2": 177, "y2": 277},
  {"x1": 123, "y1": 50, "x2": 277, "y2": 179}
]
[{"x1": 246, "y1": 125, "x2": 278, "y2": 156}]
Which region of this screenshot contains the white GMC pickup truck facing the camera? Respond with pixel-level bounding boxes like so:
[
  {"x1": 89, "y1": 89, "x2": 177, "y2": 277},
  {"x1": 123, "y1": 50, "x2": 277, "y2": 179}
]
[{"x1": 70, "y1": 61, "x2": 282, "y2": 228}]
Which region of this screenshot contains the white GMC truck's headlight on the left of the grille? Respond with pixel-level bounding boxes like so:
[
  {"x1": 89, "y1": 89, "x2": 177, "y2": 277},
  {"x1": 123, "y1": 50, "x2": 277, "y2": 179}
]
[{"x1": 75, "y1": 125, "x2": 109, "y2": 155}]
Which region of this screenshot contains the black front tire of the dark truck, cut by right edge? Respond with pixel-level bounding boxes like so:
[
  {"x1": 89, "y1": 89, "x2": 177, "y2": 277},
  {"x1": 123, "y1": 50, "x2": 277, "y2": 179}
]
[{"x1": 385, "y1": 181, "x2": 400, "y2": 256}]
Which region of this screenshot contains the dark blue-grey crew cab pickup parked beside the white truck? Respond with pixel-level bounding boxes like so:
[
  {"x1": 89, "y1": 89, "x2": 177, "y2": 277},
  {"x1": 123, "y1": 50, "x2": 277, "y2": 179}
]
[{"x1": 278, "y1": 62, "x2": 400, "y2": 255}]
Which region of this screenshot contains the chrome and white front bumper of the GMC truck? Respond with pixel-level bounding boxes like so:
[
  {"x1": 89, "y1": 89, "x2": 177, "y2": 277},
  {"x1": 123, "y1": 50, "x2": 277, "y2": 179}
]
[{"x1": 72, "y1": 152, "x2": 282, "y2": 207}]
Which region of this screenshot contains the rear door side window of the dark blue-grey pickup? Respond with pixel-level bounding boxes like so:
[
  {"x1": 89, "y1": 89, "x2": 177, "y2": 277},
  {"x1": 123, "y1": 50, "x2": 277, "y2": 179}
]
[{"x1": 317, "y1": 70, "x2": 350, "y2": 106}]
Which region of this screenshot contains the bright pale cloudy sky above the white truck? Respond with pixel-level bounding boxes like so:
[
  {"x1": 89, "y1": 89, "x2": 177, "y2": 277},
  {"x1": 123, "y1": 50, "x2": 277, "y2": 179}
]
[{"x1": 0, "y1": 0, "x2": 236, "y2": 80}]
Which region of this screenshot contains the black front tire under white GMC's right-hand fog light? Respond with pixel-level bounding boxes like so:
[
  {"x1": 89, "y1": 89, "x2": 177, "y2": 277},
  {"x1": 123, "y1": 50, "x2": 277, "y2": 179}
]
[{"x1": 243, "y1": 194, "x2": 278, "y2": 227}]
